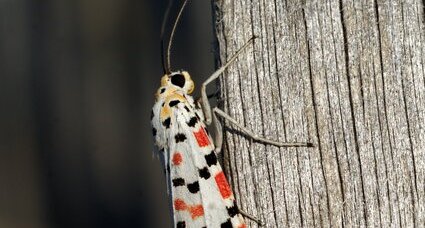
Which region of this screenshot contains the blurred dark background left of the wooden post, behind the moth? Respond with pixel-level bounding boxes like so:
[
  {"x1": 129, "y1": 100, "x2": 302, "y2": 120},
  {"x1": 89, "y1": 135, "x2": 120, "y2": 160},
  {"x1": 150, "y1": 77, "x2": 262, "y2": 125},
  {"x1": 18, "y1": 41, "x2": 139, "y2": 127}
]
[{"x1": 0, "y1": 0, "x2": 214, "y2": 228}]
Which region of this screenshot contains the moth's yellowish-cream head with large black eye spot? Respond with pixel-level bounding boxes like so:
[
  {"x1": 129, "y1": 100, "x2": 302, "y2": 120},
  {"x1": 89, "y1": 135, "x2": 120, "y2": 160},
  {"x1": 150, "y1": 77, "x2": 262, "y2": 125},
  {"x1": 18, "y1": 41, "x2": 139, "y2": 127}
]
[{"x1": 161, "y1": 71, "x2": 195, "y2": 94}]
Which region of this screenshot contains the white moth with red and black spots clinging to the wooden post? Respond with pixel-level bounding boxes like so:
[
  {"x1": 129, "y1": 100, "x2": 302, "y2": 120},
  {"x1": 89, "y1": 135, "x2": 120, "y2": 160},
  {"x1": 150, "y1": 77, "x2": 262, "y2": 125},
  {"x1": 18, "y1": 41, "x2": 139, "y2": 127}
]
[{"x1": 151, "y1": 0, "x2": 311, "y2": 228}]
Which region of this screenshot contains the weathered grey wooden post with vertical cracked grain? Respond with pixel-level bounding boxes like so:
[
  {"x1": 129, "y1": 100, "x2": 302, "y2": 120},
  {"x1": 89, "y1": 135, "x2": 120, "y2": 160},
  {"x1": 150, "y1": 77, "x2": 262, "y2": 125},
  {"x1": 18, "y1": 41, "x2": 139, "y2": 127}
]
[{"x1": 213, "y1": 0, "x2": 425, "y2": 227}]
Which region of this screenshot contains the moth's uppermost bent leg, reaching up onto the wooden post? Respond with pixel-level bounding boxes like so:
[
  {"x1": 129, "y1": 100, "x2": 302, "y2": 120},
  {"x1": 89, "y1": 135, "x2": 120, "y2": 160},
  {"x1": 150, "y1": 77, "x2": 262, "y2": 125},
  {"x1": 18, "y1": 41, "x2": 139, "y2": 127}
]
[{"x1": 201, "y1": 36, "x2": 256, "y2": 125}]
